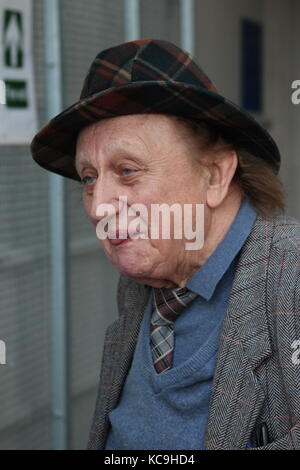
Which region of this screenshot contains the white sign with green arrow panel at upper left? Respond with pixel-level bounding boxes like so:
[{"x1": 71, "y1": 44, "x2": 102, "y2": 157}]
[{"x1": 0, "y1": 0, "x2": 37, "y2": 142}]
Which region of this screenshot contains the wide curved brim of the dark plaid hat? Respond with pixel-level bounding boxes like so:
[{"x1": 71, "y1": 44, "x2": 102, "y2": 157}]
[{"x1": 31, "y1": 81, "x2": 280, "y2": 181}]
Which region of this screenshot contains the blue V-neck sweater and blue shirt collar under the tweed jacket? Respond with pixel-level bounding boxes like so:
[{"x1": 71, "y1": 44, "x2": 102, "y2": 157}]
[{"x1": 106, "y1": 199, "x2": 257, "y2": 450}]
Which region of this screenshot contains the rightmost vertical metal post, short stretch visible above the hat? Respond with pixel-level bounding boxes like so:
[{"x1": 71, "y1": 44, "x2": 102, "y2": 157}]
[{"x1": 180, "y1": 0, "x2": 195, "y2": 56}]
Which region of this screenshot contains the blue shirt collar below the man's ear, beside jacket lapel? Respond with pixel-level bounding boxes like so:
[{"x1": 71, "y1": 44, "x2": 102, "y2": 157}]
[{"x1": 186, "y1": 198, "x2": 257, "y2": 300}]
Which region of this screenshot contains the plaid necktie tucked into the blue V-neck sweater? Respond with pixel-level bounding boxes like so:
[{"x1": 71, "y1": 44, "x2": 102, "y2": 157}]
[{"x1": 150, "y1": 287, "x2": 198, "y2": 374}]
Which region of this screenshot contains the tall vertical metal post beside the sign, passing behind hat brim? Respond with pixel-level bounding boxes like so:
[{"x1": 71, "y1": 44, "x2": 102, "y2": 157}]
[{"x1": 43, "y1": 0, "x2": 69, "y2": 450}]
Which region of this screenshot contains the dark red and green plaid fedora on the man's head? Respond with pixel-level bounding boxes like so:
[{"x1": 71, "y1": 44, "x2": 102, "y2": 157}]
[{"x1": 31, "y1": 39, "x2": 280, "y2": 181}]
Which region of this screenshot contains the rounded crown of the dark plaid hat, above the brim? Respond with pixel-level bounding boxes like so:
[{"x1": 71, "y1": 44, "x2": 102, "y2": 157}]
[{"x1": 80, "y1": 39, "x2": 218, "y2": 99}]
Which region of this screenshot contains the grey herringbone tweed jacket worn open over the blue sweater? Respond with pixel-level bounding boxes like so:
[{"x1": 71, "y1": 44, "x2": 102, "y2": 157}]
[{"x1": 88, "y1": 213, "x2": 300, "y2": 450}]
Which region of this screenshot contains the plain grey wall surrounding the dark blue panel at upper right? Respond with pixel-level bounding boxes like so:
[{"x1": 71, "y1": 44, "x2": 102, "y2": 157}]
[{"x1": 195, "y1": 0, "x2": 300, "y2": 219}]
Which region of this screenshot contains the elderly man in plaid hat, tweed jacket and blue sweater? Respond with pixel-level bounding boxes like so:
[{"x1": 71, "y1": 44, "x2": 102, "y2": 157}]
[{"x1": 32, "y1": 40, "x2": 300, "y2": 450}]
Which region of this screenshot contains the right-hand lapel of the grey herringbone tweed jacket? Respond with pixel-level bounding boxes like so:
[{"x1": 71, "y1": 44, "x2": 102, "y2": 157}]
[{"x1": 205, "y1": 216, "x2": 273, "y2": 449}]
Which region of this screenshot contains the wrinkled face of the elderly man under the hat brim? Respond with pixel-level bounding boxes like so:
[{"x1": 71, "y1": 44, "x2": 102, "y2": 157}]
[{"x1": 76, "y1": 114, "x2": 208, "y2": 287}]
